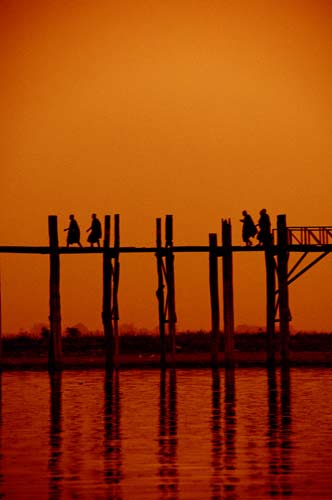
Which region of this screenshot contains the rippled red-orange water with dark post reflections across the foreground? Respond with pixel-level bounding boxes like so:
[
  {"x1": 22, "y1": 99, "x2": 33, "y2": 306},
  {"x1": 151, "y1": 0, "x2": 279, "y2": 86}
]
[{"x1": 0, "y1": 368, "x2": 332, "y2": 500}]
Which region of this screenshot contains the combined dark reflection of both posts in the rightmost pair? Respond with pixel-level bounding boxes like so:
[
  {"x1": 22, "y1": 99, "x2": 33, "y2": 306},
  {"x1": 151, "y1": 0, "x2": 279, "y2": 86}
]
[{"x1": 267, "y1": 367, "x2": 292, "y2": 498}]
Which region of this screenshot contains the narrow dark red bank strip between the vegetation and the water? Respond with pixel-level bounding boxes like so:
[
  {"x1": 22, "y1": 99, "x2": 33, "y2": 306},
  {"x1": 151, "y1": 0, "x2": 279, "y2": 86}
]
[{"x1": 1, "y1": 351, "x2": 332, "y2": 372}]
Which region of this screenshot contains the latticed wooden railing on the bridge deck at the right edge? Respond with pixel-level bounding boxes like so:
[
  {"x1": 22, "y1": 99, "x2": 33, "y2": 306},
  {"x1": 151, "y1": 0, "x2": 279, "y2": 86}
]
[{"x1": 273, "y1": 226, "x2": 332, "y2": 245}]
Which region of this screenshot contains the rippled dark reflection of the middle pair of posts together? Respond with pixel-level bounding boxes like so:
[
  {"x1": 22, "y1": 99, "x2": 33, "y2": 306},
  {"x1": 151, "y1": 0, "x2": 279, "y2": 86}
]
[{"x1": 158, "y1": 369, "x2": 178, "y2": 500}]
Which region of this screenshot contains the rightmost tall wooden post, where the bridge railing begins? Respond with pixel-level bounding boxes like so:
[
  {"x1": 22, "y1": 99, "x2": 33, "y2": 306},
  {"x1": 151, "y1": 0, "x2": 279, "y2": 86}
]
[{"x1": 277, "y1": 215, "x2": 290, "y2": 363}]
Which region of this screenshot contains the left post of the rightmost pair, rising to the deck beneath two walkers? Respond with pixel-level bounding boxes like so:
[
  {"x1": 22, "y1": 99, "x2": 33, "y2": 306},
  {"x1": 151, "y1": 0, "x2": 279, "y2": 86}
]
[{"x1": 265, "y1": 246, "x2": 276, "y2": 367}]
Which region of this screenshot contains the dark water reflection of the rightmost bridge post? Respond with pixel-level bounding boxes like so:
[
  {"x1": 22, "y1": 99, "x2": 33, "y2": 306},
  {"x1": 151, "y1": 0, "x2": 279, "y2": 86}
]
[{"x1": 280, "y1": 366, "x2": 293, "y2": 497}]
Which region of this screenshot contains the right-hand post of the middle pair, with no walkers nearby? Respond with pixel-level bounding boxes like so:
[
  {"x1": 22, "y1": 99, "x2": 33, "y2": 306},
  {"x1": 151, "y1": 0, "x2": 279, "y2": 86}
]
[{"x1": 166, "y1": 215, "x2": 176, "y2": 362}]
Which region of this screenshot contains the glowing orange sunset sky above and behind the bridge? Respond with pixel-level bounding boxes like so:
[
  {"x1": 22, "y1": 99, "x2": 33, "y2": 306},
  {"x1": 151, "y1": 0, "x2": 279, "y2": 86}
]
[{"x1": 0, "y1": 0, "x2": 332, "y2": 332}]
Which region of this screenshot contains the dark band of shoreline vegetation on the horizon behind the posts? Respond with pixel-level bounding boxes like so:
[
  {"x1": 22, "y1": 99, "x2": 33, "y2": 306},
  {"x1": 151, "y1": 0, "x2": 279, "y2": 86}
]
[{"x1": 2, "y1": 331, "x2": 332, "y2": 357}]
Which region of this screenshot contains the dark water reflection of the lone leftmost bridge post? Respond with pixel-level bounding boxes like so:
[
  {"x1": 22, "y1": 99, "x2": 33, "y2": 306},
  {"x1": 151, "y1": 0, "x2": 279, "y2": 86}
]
[{"x1": 48, "y1": 372, "x2": 62, "y2": 500}]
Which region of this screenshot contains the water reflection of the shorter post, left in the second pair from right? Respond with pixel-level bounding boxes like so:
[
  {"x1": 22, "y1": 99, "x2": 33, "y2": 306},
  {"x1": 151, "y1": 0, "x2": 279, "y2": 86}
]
[{"x1": 211, "y1": 369, "x2": 222, "y2": 500}]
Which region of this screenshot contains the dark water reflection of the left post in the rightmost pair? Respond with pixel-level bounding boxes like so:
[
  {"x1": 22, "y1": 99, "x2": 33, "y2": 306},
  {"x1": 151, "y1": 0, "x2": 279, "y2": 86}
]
[{"x1": 267, "y1": 368, "x2": 280, "y2": 498}]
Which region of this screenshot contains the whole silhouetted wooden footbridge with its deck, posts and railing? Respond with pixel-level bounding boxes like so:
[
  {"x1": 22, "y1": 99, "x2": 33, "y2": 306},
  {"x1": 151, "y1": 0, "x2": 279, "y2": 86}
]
[{"x1": 0, "y1": 214, "x2": 332, "y2": 370}]
